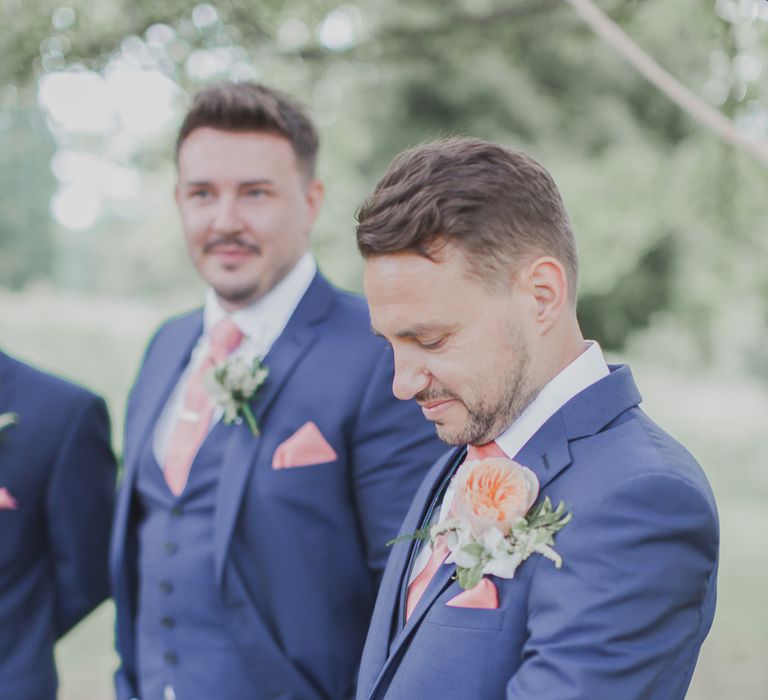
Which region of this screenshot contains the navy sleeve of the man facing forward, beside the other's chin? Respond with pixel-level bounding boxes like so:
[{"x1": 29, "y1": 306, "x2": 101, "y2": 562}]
[{"x1": 350, "y1": 346, "x2": 447, "y2": 577}]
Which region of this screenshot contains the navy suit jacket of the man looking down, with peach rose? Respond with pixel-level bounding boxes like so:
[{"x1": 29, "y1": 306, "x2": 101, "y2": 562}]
[{"x1": 357, "y1": 367, "x2": 718, "y2": 700}]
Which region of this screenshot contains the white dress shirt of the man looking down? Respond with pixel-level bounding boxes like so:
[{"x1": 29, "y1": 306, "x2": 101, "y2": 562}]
[{"x1": 408, "y1": 340, "x2": 610, "y2": 585}]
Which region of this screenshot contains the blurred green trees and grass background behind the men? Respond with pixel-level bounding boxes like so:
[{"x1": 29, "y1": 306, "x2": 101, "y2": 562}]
[{"x1": 0, "y1": 0, "x2": 768, "y2": 700}]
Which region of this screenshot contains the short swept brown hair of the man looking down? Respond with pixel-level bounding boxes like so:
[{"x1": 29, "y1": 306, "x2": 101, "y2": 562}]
[{"x1": 357, "y1": 138, "x2": 578, "y2": 303}]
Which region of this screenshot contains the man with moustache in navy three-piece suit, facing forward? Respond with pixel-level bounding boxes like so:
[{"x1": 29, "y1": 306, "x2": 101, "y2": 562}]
[{"x1": 111, "y1": 83, "x2": 445, "y2": 700}]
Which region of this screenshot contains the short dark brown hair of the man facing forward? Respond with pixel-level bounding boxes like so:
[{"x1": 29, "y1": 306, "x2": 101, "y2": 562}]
[{"x1": 176, "y1": 82, "x2": 320, "y2": 178}]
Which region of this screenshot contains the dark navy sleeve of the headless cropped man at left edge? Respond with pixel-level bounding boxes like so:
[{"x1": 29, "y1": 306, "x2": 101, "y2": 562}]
[{"x1": 46, "y1": 395, "x2": 116, "y2": 637}]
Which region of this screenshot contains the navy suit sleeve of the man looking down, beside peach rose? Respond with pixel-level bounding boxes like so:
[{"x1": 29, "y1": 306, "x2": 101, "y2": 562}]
[{"x1": 506, "y1": 474, "x2": 718, "y2": 700}]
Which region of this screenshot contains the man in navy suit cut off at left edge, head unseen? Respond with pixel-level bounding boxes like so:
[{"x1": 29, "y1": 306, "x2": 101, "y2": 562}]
[{"x1": 0, "y1": 352, "x2": 116, "y2": 700}]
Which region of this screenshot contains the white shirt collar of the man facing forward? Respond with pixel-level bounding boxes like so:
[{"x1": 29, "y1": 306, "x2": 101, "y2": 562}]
[{"x1": 203, "y1": 252, "x2": 317, "y2": 356}]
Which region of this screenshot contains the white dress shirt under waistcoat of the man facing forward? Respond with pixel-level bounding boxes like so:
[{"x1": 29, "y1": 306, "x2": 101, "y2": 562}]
[{"x1": 152, "y1": 253, "x2": 317, "y2": 467}]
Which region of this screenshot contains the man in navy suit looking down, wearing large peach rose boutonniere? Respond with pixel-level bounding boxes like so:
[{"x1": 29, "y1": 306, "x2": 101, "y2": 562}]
[{"x1": 357, "y1": 139, "x2": 718, "y2": 700}]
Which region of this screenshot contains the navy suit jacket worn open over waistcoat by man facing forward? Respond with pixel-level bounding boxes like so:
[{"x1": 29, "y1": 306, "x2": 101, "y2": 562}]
[{"x1": 111, "y1": 274, "x2": 445, "y2": 700}]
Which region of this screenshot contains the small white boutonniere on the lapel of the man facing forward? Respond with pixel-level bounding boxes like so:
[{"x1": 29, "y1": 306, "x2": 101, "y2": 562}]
[{"x1": 206, "y1": 357, "x2": 269, "y2": 436}]
